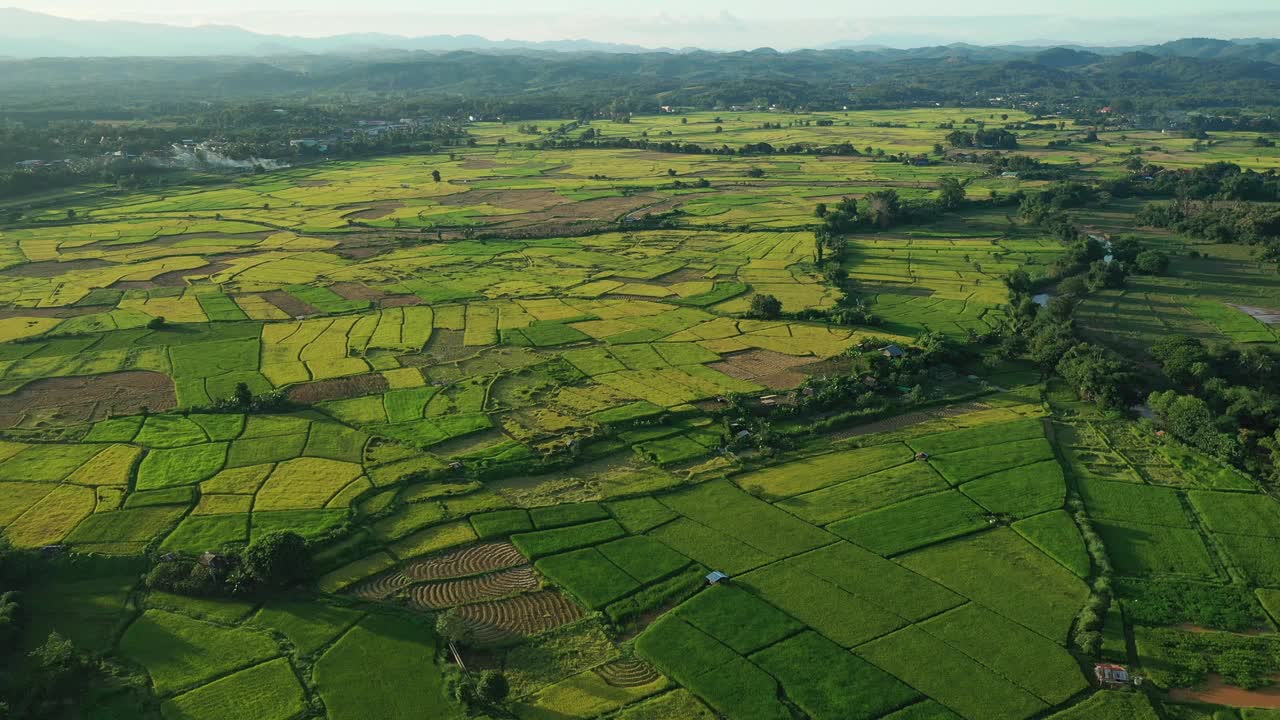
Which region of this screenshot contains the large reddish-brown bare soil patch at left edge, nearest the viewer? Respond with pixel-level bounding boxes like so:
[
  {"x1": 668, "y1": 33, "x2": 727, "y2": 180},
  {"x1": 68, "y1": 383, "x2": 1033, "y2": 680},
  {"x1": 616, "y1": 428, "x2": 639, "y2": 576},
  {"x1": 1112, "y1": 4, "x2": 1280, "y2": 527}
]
[{"x1": 0, "y1": 370, "x2": 178, "y2": 428}]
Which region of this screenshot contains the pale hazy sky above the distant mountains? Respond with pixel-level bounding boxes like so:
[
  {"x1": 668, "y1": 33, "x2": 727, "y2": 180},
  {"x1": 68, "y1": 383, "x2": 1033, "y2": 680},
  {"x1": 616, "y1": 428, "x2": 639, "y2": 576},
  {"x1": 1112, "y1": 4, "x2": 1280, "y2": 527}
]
[{"x1": 10, "y1": 0, "x2": 1280, "y2": 49}]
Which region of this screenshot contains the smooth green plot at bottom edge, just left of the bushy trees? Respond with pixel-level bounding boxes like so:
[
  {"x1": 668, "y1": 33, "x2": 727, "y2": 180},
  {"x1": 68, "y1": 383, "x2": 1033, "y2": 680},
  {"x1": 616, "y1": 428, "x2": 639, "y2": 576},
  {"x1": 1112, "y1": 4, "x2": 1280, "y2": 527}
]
[{"x1": 312, "y1": 615, "x2": 462, "y2": 720}]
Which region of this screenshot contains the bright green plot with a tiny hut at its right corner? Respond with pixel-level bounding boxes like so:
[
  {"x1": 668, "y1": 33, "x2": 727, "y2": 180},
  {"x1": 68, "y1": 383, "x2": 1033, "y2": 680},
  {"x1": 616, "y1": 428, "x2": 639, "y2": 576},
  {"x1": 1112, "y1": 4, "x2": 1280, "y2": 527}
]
[{"x1": 827, "y1": 491, "x2": 988, "y2": 555}]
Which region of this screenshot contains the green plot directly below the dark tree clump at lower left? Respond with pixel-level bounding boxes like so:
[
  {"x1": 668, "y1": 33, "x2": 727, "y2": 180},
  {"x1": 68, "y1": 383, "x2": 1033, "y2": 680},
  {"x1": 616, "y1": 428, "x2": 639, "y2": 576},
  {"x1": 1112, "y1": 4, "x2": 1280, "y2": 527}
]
[{"x1": 120, "y1": 610, "x2": 279, "y2": 694}]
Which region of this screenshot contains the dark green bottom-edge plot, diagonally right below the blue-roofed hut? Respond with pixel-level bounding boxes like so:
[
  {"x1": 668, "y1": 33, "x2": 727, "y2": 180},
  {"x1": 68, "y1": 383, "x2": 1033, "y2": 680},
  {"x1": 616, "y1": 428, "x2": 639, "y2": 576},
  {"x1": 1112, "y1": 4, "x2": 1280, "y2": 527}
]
[{"x1": 751, "y1": 632, "x2": 920, "y2": 720}]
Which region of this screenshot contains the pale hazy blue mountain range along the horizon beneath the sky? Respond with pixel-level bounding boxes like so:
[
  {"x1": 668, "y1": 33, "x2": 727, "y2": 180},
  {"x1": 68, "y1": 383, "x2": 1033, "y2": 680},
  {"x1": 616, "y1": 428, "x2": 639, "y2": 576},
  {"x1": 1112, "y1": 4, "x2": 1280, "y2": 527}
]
[{"x1": 0, "y1": 8, "x2": 1280, "y2": 59}]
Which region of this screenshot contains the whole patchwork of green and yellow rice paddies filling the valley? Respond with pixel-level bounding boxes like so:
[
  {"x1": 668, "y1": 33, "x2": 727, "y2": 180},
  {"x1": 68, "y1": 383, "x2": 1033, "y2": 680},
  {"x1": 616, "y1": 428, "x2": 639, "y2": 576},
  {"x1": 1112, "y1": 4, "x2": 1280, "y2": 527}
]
[{"x1": 0, "y1": 108, "x2": 1280, "y2": 720}]
